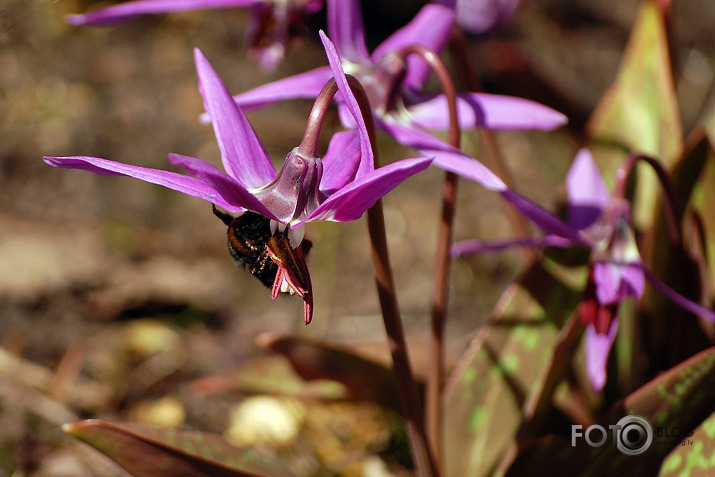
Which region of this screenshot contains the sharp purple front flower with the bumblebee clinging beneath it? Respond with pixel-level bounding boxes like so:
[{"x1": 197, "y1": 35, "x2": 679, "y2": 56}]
[{"x1": 44, "y1": 50, "x2": 431, "y2": 323}]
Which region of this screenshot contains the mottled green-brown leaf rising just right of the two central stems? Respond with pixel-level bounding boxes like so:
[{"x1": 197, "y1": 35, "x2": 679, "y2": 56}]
[{"x1": 443, "y1": 262, "x2": 585, "y2": 477}]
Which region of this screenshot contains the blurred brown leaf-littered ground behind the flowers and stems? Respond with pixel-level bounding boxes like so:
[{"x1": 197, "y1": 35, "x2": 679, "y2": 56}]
[{"x1": 0, "y1": 0, "x2": 715, "y2": 476}]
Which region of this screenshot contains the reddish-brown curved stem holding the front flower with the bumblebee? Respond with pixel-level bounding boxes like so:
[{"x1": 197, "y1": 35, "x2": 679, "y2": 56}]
[{"x1": 314, "y1": 75, "x2": 440, "y2": 477}]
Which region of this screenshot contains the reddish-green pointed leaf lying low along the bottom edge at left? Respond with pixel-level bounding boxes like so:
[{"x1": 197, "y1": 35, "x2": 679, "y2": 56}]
[{"x1": 64, "y1": 419, "x2": 291, "y2": 477}]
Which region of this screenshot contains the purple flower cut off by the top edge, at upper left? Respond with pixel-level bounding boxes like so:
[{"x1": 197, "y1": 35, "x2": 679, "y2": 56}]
[{"x1": 66, "y1": 0, "x2": 323, "y2": 70}]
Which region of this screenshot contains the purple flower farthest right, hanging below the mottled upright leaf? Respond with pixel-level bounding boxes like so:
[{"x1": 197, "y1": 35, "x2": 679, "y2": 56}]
[{"x1": 452, "y1": 149, "x2": 715, "y2": 391}]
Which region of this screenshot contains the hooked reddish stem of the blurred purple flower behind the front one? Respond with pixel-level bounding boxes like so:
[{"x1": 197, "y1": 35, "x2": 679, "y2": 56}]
[{"x1": 399, "y1": 45, "x2": 460, "y2": 462}]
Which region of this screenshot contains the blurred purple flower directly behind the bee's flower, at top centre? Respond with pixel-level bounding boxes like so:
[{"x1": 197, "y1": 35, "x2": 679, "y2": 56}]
[{"x1": 221, "y1": 0, "x2": 566, "y2": 191}]
